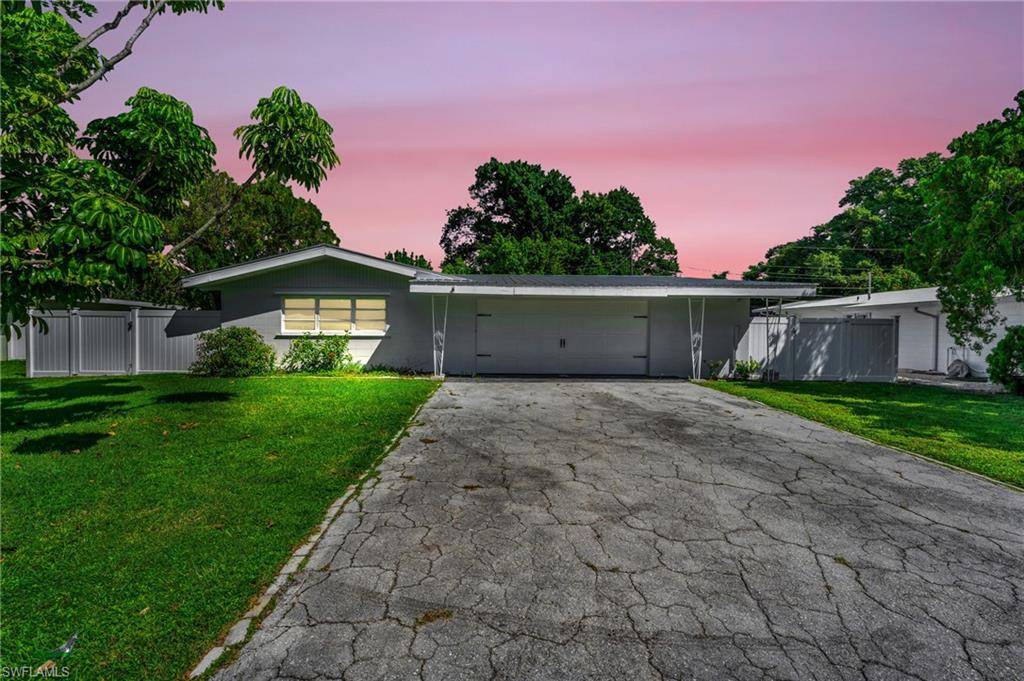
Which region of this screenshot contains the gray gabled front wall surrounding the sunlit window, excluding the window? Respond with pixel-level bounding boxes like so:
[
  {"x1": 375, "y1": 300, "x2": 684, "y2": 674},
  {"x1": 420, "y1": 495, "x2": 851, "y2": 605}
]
[{"x1": 220, "y1": 259, "x2": 436, "y2": 372}]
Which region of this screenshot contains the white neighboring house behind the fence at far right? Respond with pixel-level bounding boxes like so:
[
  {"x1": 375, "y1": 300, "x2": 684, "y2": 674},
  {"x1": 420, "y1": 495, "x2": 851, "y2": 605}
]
[{"x1": 781, "y1": 288, "x2": 1024, "y2": 376}]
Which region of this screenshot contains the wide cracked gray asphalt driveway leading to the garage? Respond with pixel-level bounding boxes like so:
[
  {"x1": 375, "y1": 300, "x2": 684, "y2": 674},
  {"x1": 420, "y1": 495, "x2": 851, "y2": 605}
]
[{"x1": 211, "y1": 380, "x2": 1024, "y2": 680}]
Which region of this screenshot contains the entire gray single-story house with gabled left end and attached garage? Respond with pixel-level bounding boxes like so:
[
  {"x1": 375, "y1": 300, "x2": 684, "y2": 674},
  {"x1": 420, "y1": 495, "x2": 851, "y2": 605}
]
[{"x1": 183, "y1": 246, "x2": 814, "y2": 376}]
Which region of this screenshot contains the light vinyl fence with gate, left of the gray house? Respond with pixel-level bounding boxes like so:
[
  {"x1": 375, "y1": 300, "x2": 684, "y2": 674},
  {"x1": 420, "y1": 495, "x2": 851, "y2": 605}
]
[{"x1": 25, "y1": 308, "x2": 220, "y2": 378}]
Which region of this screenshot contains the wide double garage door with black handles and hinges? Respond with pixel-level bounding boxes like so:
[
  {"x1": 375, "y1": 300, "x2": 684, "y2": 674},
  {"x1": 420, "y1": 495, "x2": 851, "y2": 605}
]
[{"x1": 476, "y1": 298, "x2": 647, "y2": 375}]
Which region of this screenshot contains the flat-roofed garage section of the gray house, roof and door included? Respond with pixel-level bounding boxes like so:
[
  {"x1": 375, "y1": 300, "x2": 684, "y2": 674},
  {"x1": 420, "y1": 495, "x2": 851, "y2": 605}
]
[{"x1": 410, "y1": 274, "x2": 814, "y2": 378}]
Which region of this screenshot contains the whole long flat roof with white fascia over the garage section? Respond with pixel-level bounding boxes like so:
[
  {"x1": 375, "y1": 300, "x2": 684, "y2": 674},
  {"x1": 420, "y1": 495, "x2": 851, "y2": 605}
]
[{"x1": 411, "y1": 274, "x2": 815, "y2": 298}]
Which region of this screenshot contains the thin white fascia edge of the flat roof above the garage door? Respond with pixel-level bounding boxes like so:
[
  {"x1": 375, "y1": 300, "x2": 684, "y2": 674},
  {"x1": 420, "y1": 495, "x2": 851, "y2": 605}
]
[{"x1": 409, "y1": 282, "x2": 815, "y2": 298}]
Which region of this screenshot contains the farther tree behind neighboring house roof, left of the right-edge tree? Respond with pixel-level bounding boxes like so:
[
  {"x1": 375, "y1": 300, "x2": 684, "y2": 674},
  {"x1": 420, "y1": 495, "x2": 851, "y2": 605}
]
[{"x1": 743, "y1": 154, "x2": 941, "y2": 296}]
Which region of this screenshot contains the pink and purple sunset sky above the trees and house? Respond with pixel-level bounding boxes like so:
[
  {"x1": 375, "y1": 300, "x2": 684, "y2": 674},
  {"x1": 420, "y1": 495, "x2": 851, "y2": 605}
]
[{"x1": 72, "y1": 2, "x2": 1024, "y2": 276}]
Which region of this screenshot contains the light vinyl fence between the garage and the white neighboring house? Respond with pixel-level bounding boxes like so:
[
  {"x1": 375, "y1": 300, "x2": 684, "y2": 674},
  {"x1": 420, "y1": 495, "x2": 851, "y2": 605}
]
[{"x1": 736, "y1": 316, "x2": 899, "y2": 382}]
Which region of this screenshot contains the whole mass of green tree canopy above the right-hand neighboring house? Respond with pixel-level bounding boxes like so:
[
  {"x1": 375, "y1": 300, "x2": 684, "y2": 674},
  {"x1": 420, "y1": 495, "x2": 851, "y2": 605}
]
[{"x1": 743, "y1": 90, "x2": 1024, "y2": 349}]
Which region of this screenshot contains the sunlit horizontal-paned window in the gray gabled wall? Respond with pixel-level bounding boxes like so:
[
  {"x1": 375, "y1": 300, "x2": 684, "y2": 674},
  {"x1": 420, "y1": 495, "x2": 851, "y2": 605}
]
[{"x1": 281, "y1": 298, "x2": 387, "y2": 334}]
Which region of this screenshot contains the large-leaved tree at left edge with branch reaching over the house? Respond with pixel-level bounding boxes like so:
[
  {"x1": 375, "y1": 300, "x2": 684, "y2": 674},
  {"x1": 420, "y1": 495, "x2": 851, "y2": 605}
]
[{"x1": 0, "y1": 0, "x2": 338, "y2": 335}]
